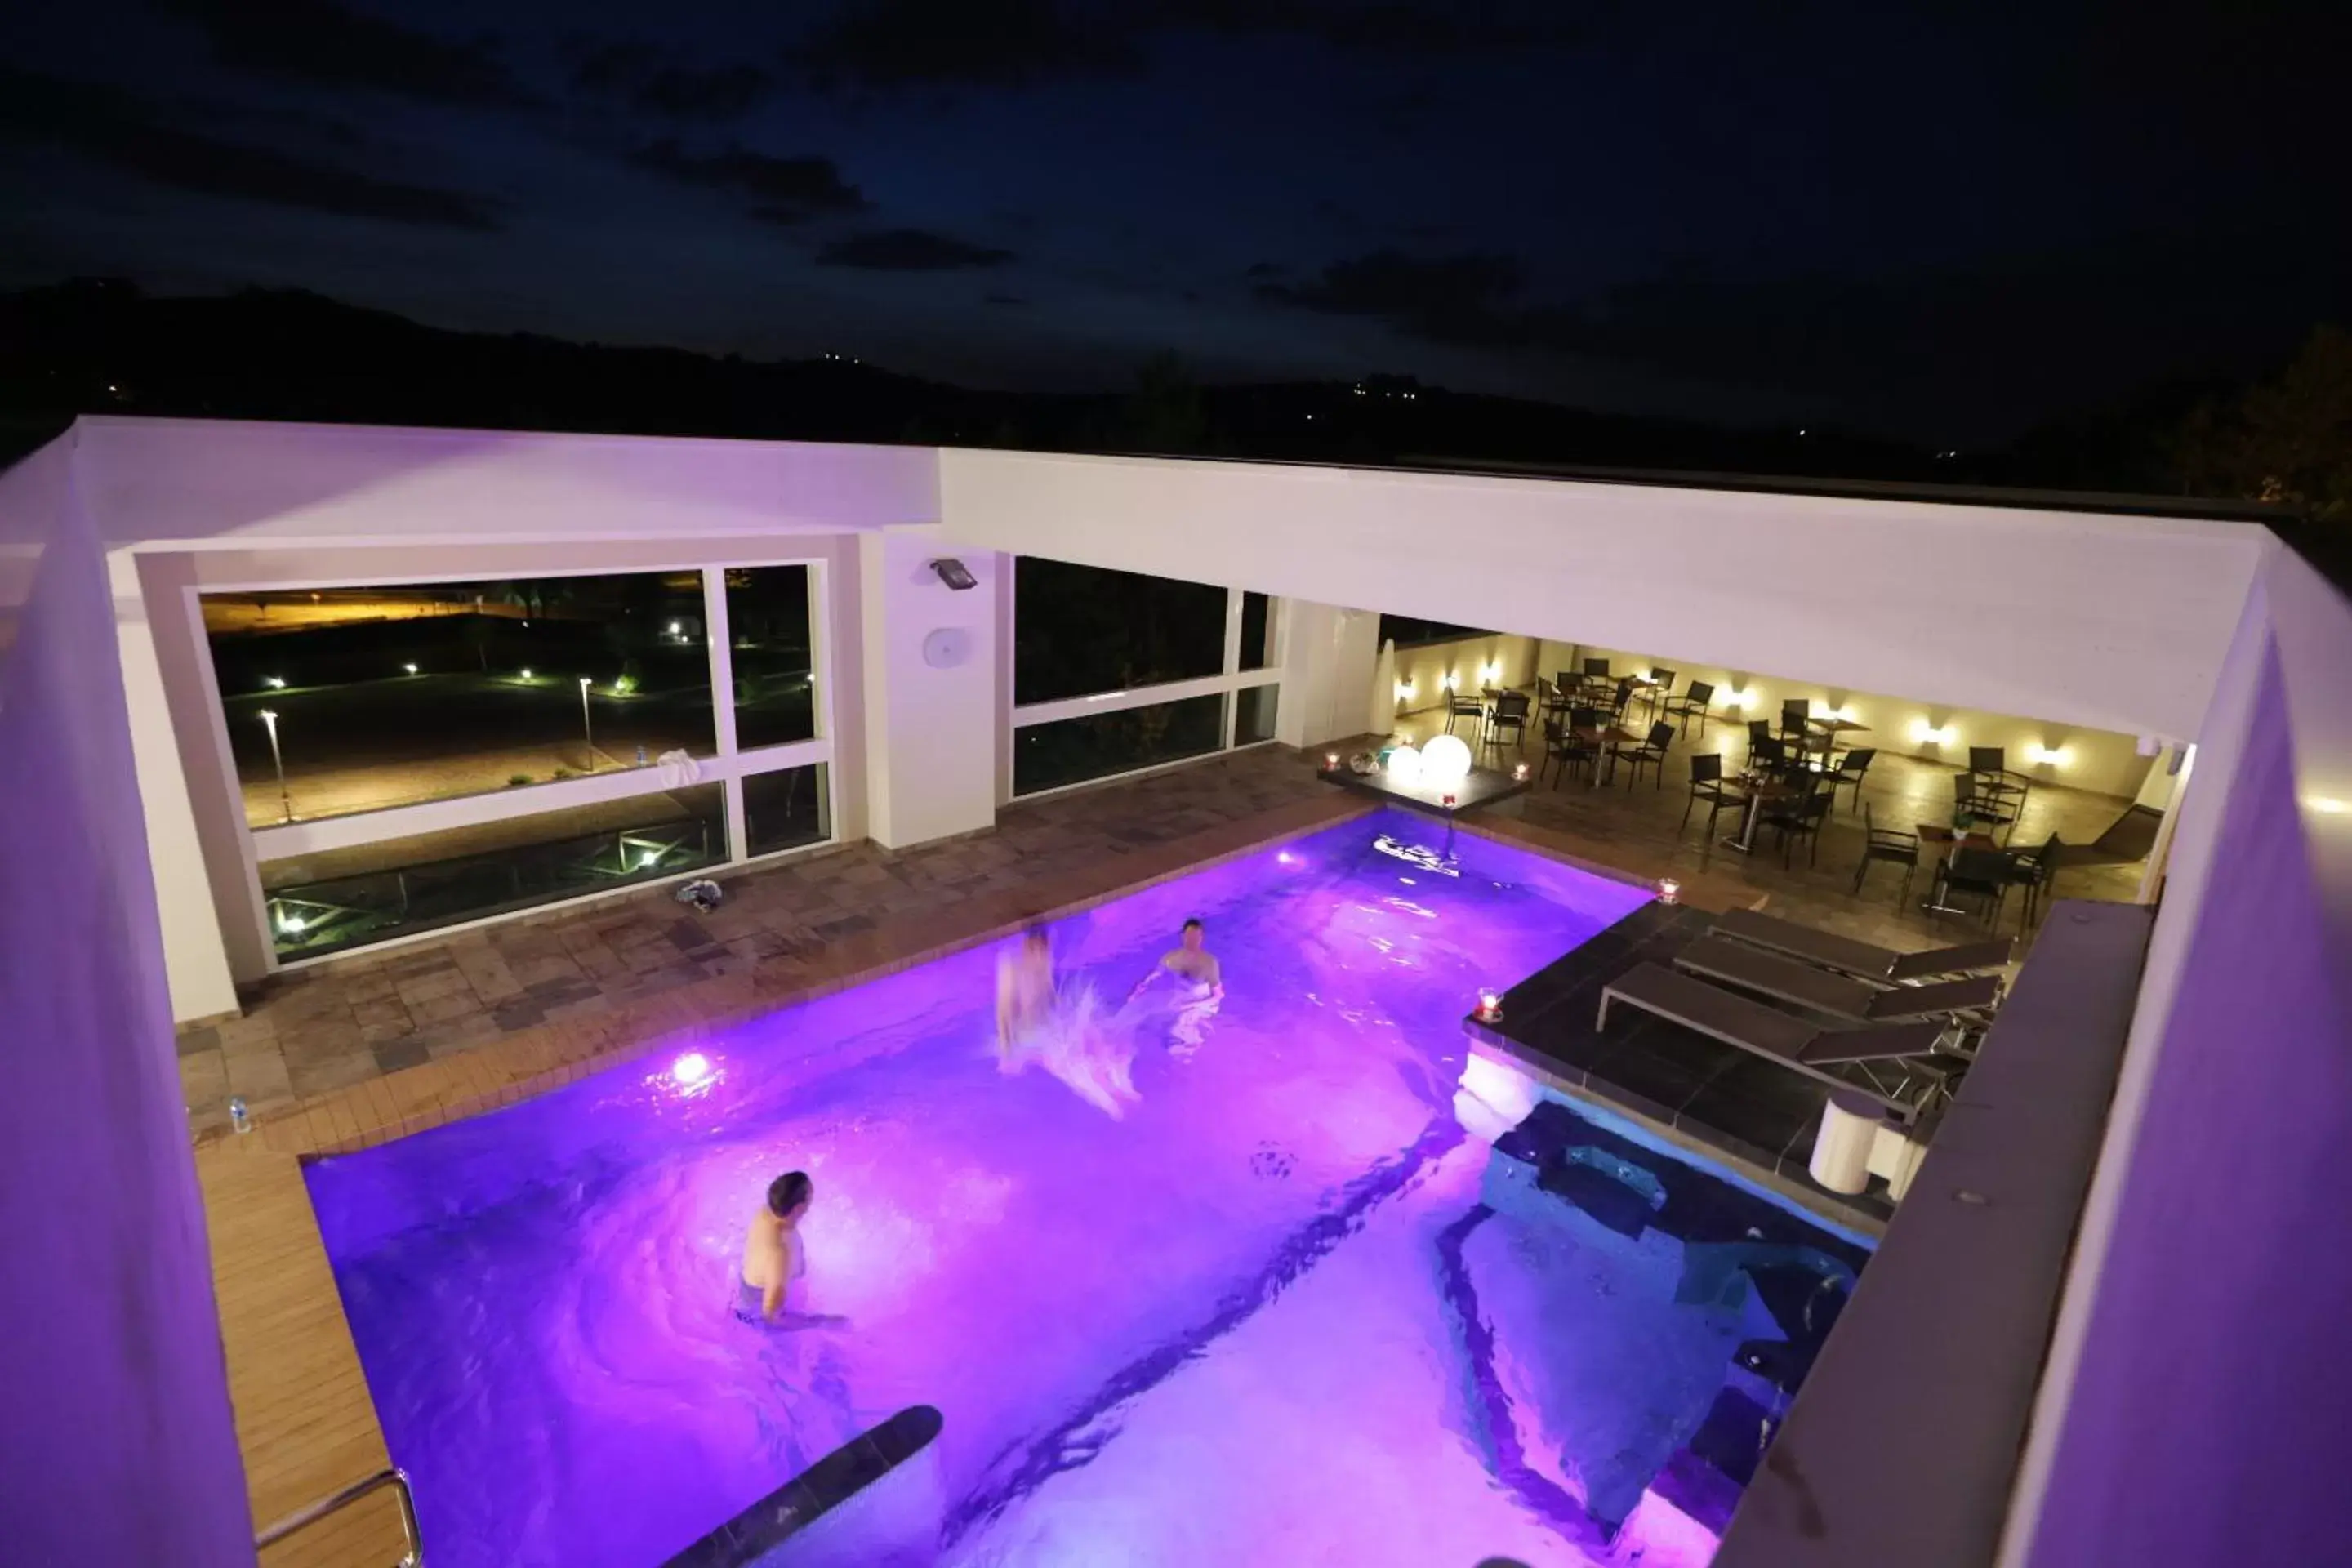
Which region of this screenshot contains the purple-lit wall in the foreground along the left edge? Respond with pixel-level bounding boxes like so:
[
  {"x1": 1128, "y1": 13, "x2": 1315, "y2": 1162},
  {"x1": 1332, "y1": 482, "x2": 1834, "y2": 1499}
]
[{"x1": 0, "y1": 437, "x2": 254, "y2": 1568}]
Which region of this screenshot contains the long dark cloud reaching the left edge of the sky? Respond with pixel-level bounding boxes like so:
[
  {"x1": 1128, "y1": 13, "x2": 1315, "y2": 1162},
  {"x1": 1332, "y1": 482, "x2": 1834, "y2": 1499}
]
[{"x1": 0, "y1": 66, "x2": 499, "y2": 230}]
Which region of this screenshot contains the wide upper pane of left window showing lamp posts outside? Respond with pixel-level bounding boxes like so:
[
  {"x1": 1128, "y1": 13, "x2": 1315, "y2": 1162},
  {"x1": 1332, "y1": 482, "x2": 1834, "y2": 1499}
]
[{"x1": 203, "y1": 571, "x2": 713, "y2": 825}]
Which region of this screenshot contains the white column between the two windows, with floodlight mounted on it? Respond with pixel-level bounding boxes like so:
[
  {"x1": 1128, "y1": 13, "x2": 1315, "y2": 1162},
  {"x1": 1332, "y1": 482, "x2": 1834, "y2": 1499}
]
[{"x1": 858, "y1": 527, "x2": 1011, "y2": 849}]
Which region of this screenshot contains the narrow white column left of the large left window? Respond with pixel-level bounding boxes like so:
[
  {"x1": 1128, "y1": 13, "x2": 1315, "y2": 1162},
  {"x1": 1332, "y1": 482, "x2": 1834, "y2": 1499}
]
[{"x1": 106, "y1": 550, "x2": 238, "y2": 1022}]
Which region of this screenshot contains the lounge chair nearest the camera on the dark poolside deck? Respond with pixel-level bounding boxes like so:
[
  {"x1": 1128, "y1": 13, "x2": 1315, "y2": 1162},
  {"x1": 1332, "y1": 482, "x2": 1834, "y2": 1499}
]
[{"x1": 1595, "y1": 964, "x2": 1957, "y2": 1124}]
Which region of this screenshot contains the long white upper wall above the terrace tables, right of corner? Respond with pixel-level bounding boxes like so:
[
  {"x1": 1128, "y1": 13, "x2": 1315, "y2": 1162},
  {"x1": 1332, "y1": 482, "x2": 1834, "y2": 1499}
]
[{"x1": 938, "y1": 449, "x2": 2267, "y2": 736}]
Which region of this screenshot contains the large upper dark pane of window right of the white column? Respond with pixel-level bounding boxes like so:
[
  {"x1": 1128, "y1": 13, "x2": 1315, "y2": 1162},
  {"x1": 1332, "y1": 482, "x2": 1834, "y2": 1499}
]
[{"x1": 1013, "y1": 555, "x2": 1225, "y2": 703}]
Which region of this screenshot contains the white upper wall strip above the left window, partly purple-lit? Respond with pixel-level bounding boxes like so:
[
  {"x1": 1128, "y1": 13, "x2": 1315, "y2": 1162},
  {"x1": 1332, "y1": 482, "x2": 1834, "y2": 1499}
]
[{"x1": 75, "y1": 418, "x2": 917, "y2": 546}]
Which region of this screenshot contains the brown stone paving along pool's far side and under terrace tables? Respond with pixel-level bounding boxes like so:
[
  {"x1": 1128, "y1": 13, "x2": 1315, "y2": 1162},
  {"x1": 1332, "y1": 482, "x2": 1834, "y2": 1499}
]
[{"x1": 179, "y1": 719, "x2": 2138, "y2": 1135}]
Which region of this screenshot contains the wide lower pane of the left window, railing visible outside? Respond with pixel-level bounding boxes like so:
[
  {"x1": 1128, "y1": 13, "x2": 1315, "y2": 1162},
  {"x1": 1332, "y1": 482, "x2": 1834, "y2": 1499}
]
[{"x1": 261, "y1": 785, "x2": 727, "y2": 959}]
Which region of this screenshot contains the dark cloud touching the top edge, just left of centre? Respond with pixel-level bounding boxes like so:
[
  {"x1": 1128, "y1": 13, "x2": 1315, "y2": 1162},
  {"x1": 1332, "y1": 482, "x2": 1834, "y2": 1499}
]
[{"x1": 786, "y1": 0, "x2": 1143, "y2": 91}]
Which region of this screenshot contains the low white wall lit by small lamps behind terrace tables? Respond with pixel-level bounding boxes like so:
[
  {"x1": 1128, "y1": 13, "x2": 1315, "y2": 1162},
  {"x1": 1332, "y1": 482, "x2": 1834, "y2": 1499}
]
[{"x1": 1543, "y1": 642, "x2": 2149, "y2": 797}]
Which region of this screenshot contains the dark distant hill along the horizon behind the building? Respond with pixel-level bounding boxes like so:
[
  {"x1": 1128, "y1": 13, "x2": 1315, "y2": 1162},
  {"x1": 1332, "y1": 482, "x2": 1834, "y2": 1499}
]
[{"x1": 0, "y1": 280, "x2": 2182, "y2": 487}]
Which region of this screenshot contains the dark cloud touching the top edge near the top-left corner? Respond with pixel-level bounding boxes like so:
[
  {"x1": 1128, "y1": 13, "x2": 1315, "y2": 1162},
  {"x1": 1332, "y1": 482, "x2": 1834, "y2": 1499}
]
[{"x1": 148, "y1": 0, "x2": 532, "y2": 106}]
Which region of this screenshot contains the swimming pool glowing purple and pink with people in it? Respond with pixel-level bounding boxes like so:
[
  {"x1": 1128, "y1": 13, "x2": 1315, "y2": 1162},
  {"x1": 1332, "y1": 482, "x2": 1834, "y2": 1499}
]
[{"x1": 308, "y1": 813, "x2": 1862, "y2": 1568}]
